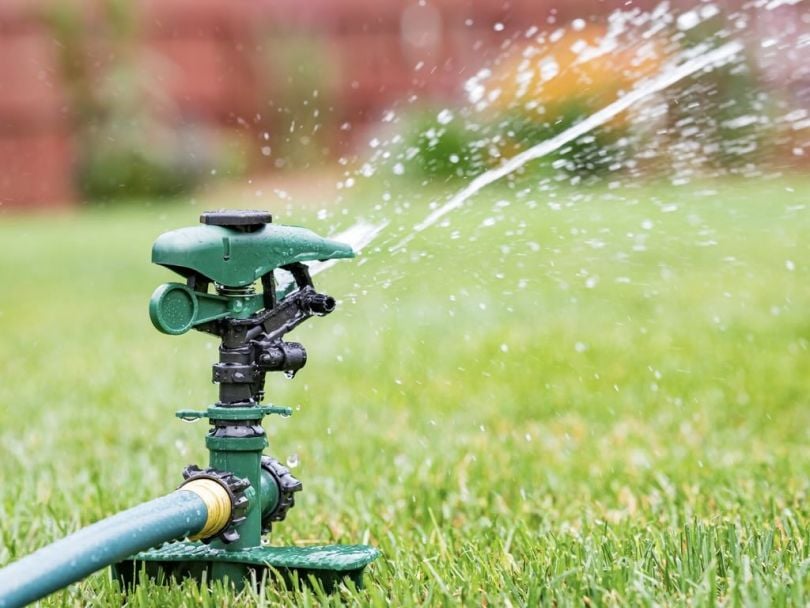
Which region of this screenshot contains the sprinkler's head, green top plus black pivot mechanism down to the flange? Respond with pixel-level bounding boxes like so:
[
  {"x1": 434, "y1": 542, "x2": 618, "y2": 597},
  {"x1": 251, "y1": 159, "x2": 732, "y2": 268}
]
[{"x1": 149, "y1": 210, "x2": 354, "y2": 405}]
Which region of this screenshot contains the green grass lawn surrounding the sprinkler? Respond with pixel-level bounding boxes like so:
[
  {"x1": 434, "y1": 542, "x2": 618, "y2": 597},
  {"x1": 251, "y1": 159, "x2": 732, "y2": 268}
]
[{"x1": 0, "y1": 180, "x2": 810, "y2": 606}]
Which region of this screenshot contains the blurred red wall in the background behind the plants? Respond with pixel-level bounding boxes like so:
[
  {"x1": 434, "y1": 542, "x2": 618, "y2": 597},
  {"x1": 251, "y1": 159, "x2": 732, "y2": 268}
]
[{"x1": 0, "y1": 0, "x2": 652, "y2": 207}]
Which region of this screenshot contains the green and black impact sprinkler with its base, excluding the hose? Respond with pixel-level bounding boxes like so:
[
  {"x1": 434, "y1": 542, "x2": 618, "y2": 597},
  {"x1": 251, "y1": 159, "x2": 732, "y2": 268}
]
[{"x1": 114, "y1": 210, "x2": 379, "y2": 588}]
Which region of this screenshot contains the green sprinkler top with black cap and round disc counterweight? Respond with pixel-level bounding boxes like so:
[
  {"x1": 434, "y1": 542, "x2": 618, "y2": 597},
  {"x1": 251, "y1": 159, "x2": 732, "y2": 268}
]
[{"x1": 149, "y1": 210, "x2": 354, "y2": 335}]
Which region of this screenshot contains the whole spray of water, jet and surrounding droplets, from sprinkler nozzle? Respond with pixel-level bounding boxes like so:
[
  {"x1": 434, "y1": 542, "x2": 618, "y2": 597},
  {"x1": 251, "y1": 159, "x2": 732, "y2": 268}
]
[{"x1": 288, "y1": 0, "x2": 810, "y2": 292}]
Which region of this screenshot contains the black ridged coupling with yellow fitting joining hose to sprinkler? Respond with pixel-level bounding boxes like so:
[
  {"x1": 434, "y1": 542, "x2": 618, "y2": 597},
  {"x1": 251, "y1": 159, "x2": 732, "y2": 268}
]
[{"x1": 178, "y1": 465, "x2": 250, "y2": 544}]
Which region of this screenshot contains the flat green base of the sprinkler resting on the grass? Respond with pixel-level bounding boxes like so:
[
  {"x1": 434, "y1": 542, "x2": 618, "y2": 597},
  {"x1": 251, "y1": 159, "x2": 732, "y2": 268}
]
[{"x1": 113, "y1": 542, "x2": 380, "y2": 591}]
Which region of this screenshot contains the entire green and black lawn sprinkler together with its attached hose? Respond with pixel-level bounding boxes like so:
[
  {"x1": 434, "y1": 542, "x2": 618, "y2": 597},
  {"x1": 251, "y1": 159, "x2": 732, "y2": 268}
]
[{"x1": 0, "y1": 210, "x2": 379, "y2": 608}]
